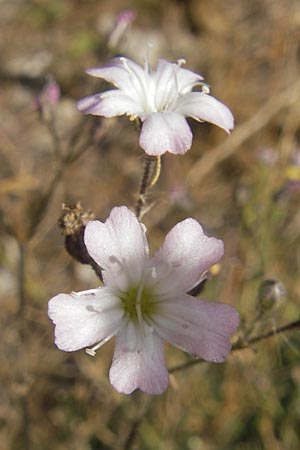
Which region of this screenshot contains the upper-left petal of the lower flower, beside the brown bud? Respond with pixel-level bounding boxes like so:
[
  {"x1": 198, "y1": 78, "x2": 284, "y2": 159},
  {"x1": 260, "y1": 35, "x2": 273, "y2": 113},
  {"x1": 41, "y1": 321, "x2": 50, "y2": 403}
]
[{"x1": 84, "y1": 206, "x2": 149, "y2": 291}]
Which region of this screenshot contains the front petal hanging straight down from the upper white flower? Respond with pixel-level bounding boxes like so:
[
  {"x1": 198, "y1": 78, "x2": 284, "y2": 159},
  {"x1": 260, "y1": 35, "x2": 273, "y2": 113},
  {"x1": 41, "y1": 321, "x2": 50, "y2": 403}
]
[{"x1": 140, "y1": 112, "x2": 193, "y2": 155}]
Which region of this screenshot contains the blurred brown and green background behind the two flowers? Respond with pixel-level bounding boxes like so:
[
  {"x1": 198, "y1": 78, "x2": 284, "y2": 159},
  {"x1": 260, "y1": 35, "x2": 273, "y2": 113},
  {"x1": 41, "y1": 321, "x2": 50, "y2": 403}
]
[{"x1": 0, "y1": 0, "x2": 300, "y2": 450}]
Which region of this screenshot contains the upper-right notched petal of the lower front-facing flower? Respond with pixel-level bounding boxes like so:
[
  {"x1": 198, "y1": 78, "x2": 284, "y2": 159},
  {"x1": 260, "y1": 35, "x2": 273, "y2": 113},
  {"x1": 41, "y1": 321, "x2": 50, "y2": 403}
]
[{"x1": 151, "y1": 219, "x2": 224, "y2": 295}]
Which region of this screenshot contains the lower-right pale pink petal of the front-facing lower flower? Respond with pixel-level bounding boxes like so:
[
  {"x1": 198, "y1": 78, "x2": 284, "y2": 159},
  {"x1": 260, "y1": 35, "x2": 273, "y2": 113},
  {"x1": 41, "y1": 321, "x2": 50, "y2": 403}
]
[{"x1": 152, "y1": 295, "x2": 239, "y2": 362}]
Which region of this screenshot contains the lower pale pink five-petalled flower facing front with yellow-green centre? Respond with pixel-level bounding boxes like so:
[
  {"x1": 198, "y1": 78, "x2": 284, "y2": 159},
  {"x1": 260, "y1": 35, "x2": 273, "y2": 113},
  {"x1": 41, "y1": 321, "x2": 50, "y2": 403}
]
[{"x1": 49, "y1": 206, "x2": 239, "y2": 394}]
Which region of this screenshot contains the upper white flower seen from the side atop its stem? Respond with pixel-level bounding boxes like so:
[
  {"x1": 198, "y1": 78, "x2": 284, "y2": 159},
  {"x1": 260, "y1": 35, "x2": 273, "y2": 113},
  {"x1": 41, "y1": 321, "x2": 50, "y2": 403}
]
[{"x1": 77, "y1": 57, "x2": 234, "y2": 155}]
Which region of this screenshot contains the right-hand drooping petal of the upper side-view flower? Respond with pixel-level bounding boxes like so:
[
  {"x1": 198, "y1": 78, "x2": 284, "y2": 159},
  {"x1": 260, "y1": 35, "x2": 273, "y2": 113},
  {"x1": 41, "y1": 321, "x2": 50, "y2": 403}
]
[{"x1": 175, "y1": 92, "x2": 234, "y2": 132}]
